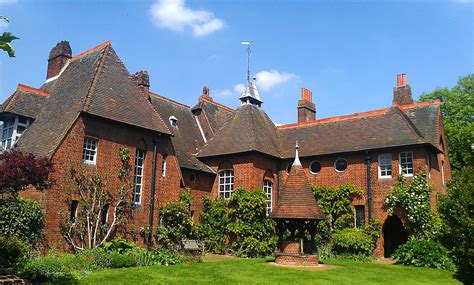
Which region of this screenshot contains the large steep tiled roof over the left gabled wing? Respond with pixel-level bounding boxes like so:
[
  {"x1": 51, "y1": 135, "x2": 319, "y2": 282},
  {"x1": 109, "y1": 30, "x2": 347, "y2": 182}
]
[{"x1": 17, "y1": 42, "x2": 170, "y2": 157}]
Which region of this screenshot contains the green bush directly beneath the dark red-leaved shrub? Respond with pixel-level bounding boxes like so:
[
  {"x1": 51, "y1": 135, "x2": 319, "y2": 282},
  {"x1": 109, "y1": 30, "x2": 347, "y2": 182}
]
[{"x1": 0, "y1": 195, "x2": 44, "y2": 246}]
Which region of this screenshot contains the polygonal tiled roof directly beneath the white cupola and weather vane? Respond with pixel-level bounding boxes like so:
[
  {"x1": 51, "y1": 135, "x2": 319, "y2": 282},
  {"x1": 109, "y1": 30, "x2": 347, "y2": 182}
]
[{"x1": 198, "y1": 104, "x2": 280, "y2": 157}]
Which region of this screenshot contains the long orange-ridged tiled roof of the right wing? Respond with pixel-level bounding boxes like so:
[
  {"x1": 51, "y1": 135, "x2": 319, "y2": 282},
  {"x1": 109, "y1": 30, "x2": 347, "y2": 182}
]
[{"x1": 278, "y1": 105, "x2": 438, "y2": 158}]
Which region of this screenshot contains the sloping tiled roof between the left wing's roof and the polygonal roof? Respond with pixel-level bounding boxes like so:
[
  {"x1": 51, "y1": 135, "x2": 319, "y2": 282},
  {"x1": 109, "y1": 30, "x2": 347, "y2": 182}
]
[{"x1": 151, "y1": 93, "x2": 215, "y2": 173}]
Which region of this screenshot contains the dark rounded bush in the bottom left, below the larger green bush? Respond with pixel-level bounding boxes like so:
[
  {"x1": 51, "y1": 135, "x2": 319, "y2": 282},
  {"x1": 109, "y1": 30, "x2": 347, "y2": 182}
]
[{"x1": 0, "y1": 237, "x2": 29, "y2": 275}]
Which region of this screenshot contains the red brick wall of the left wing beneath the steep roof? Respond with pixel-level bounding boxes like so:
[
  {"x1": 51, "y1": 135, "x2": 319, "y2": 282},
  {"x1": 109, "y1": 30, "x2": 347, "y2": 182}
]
[{"x1": 20, "y1": 114, "x2": 180, "y2": 249}]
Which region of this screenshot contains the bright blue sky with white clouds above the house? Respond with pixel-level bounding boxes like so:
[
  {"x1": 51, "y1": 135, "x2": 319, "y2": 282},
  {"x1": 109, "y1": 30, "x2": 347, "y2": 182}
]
[{"x1": 0, "y1": 0, "x2": 474, "y2": 123}]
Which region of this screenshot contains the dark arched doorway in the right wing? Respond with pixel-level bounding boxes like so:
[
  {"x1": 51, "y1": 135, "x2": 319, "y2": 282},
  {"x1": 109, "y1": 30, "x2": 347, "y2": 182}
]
[{"x1": 383, "y1": 215, "x2": 408, "y2": 257}]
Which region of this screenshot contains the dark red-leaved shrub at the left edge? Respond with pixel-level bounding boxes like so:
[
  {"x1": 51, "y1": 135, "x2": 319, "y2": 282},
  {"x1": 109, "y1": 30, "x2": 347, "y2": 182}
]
[{"x1": 0, "y1": 150, "x2": 53, "y2": 197}]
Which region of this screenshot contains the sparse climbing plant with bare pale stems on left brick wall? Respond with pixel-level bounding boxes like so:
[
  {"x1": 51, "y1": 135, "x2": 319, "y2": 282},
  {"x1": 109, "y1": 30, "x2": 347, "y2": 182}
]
[{"x1": 61, "y1": 148, "x2": 133, "y2": 250}]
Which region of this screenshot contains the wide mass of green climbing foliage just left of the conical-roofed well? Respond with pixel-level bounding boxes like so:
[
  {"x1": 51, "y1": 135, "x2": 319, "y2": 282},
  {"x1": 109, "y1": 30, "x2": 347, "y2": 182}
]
[{"x1": 201, "y1": 189, "x2": 276, "y2": 257}]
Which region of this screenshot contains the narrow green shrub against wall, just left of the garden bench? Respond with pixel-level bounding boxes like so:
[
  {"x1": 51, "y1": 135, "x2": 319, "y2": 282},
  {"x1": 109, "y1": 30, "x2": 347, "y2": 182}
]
[{"x1": 155, "y1": 190, "x2": 195, "y2": 250}]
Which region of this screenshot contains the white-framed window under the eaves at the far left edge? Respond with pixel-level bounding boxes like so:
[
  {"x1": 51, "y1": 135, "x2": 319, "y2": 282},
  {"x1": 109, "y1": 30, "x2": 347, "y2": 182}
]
[{"x1": 0, "y1": 116, "x2": 31, "y2": 150}]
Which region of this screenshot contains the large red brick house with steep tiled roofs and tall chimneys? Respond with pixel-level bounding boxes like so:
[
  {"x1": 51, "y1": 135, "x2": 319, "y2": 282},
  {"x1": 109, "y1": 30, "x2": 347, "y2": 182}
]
[{"x1": 0, "y1": 42, "x2": 451, "y2": 256}]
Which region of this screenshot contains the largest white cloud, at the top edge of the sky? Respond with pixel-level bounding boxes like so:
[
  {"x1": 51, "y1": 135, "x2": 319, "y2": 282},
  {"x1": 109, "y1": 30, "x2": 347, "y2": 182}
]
[{"x1": 150, "y1": 0, "x2": 224, "y2": 37}]
